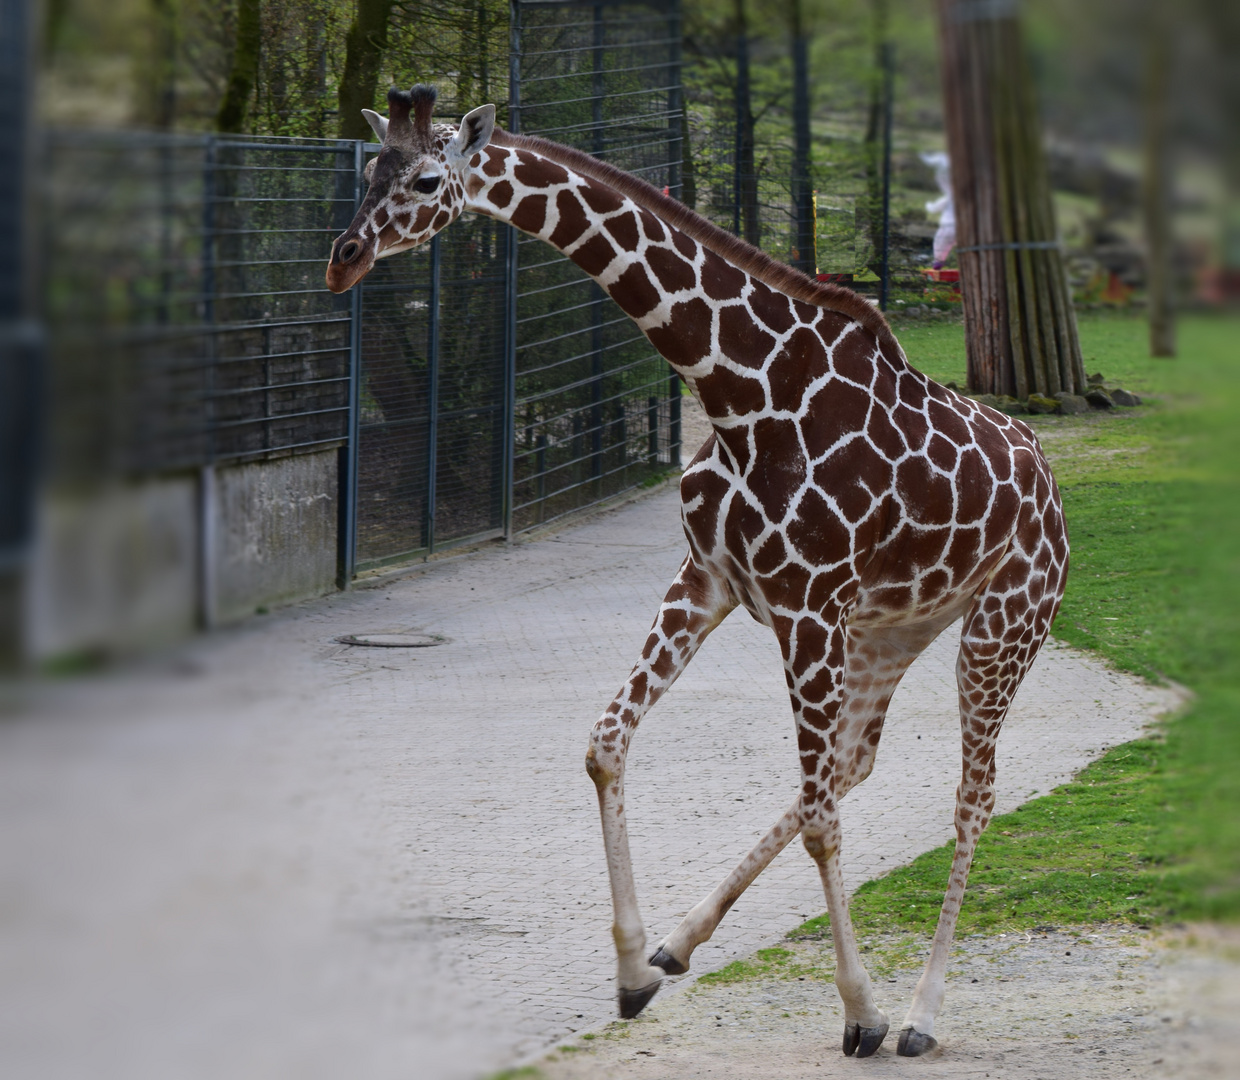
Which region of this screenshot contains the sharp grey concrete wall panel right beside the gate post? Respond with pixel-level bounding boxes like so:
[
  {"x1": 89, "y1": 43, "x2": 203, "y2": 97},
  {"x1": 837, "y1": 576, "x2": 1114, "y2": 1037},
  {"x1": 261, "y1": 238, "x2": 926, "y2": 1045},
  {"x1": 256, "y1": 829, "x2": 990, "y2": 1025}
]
[{"x1": 212, "y1": 450, "x2": 339, "y2": 622}]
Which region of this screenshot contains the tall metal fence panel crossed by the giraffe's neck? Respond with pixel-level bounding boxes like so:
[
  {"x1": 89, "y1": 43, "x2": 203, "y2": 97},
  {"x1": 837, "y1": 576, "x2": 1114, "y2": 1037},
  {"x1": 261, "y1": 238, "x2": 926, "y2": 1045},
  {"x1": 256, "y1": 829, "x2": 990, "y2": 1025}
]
[{"x1": 510, "y1": 0, "x2": 682, "y2": 531}]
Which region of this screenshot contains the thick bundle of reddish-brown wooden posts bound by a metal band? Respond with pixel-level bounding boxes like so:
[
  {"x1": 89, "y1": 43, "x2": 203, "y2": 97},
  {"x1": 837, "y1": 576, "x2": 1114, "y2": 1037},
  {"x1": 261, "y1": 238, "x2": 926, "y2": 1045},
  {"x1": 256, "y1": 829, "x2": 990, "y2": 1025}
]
[{"x1": 939, "y1": 0, "x2": 1085, "y2": 398}]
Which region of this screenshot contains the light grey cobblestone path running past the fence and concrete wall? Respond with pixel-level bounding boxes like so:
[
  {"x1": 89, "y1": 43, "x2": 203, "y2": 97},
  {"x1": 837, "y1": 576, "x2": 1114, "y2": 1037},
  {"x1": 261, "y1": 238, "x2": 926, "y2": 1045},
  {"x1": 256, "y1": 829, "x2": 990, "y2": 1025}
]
[{"x1": 0, "y1": 490, "x2": 1174, "y2": 1080}]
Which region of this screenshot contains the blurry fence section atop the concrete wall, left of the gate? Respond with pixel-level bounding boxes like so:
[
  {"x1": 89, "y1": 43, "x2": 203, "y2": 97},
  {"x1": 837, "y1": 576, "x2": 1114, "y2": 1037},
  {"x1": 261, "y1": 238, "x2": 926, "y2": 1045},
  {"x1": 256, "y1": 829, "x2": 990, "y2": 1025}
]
[{"x1": 42, "y1": 133, "x2": 356, "y2": 484}]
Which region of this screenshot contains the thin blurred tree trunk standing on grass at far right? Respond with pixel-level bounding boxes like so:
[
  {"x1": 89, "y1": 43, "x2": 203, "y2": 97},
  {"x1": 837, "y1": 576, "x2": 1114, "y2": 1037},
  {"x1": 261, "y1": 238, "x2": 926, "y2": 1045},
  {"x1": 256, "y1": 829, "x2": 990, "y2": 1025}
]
[{"x1": 1142, "y1": 25, "x2": 1176, "y2": 356}]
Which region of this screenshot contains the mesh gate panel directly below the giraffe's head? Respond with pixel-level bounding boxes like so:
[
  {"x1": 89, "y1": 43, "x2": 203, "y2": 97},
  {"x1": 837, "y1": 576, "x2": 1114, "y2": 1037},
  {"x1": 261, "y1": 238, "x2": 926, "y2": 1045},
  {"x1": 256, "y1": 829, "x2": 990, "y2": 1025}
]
[{"x1": 357, "y1": 217, "x2": 511, "y2": 568}]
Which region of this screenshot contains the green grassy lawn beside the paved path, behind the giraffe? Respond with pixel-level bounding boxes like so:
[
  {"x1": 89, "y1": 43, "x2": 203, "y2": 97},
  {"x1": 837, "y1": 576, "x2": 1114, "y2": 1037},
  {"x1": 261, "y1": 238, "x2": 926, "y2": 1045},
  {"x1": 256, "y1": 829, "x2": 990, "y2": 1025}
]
[{"x1": 793, "y1": 308, "x2": 1240, "y2": 942}]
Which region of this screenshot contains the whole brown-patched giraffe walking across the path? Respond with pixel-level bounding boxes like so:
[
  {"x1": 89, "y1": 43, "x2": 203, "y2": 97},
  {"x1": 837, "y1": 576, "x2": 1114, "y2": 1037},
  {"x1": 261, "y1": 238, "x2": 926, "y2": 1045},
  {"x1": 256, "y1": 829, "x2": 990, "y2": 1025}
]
[{"x1": 327, "y1": 86, "x2": 1068, "y2": 1058}]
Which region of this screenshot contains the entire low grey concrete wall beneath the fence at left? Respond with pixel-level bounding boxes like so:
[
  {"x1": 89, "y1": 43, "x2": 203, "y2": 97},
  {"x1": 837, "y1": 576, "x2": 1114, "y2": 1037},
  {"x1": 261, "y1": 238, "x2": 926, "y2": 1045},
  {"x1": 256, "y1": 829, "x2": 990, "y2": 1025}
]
[{"x1": 25, "y1": 449, "x2": 339, "y2": 661}]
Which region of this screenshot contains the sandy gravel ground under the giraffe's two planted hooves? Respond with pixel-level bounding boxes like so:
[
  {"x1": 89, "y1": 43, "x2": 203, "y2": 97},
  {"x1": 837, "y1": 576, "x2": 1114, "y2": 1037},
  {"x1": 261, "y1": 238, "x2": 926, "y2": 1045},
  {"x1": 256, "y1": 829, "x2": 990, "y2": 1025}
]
[{"x1": 538, "y1": 929, "x2": 1240, "y2": 1080}]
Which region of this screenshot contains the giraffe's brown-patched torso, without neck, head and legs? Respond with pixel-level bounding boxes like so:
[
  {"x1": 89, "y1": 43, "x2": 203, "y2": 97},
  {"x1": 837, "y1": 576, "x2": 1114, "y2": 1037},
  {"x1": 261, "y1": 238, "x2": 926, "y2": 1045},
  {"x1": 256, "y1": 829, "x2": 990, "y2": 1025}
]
[{"x1": 681, "y1": 324, "x2": 1054, "y2": 626}]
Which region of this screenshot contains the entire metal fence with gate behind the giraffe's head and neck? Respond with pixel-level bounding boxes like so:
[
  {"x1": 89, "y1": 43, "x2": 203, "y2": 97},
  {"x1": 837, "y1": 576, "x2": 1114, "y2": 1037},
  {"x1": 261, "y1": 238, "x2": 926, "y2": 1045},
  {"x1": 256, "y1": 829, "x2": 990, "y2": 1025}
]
[{"x1": 40, "y1": 0, "x2": 681, "y2": 579}]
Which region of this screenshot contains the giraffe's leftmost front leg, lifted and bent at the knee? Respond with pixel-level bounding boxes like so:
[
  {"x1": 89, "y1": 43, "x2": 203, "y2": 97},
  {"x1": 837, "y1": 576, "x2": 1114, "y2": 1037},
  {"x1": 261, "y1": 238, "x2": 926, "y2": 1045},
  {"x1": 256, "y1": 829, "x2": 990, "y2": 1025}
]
[{"x1": 585, "y1": 554, "x2": 735, "y2": 1019}]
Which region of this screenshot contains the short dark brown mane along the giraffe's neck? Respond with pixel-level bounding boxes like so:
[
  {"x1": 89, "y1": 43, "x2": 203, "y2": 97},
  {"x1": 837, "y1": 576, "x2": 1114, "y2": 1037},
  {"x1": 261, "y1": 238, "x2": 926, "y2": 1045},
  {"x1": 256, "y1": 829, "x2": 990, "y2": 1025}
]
[{"x1": 491, "y1": 128, "x2": 904, "y2": 356}]
